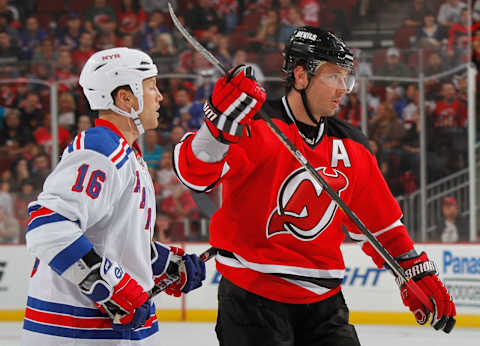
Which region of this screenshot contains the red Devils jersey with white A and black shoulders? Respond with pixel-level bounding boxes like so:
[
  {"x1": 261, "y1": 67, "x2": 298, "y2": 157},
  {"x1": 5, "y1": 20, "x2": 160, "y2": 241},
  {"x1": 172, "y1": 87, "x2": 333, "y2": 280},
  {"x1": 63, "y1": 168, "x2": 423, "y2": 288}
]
[{"x1": 174, "y1": 97, "x2": 413, "y2": 303}]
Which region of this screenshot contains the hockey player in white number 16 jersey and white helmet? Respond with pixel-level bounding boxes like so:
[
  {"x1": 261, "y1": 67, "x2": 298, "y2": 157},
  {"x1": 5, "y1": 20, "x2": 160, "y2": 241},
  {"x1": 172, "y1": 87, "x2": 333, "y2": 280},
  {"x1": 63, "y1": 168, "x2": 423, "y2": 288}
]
[{"x1": 22, "y1": 48, "x2": 205, "y2": 346}]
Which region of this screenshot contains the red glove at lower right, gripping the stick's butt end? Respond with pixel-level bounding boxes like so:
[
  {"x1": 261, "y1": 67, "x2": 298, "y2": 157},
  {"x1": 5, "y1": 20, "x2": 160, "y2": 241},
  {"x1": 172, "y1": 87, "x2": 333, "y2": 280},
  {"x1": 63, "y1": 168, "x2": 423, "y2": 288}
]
[{"x1": 397, "y1": 252, "x2": 456, "y2": 333}]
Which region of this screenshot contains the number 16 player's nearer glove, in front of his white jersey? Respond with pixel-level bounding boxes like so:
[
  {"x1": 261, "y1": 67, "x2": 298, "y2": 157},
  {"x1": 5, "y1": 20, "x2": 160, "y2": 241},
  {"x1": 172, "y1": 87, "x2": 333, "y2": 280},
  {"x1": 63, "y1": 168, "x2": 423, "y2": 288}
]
[{"x1": 79, "y1": 257, "x2": 148, "y2": 325}]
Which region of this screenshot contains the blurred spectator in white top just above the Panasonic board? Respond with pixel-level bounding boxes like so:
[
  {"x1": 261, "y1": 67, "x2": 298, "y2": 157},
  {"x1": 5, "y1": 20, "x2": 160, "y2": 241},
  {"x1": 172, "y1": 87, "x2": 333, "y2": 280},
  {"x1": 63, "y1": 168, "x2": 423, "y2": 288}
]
[{"x1": 431, "y1": 196, "x2": 470, "y2": 243}]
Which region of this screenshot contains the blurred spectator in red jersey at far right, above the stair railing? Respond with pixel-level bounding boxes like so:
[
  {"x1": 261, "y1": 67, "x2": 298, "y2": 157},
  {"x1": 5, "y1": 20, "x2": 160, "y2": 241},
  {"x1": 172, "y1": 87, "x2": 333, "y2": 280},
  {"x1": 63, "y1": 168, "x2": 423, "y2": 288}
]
[{"x1": 431, "y1": 82, "x2": 467, "y2": 172}]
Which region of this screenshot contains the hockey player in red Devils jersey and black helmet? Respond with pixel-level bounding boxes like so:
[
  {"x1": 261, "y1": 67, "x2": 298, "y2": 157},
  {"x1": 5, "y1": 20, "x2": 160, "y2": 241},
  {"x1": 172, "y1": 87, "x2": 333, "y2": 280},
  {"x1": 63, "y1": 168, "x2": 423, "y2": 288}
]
[{"x1": 174, "y1": 27, "x2": 455, "y2": 346}]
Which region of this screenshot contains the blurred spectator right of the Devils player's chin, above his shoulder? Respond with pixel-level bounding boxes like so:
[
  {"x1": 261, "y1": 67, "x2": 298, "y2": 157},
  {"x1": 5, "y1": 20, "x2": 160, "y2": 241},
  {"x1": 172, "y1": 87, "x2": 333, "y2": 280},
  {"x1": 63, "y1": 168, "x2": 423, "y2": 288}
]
[{"x1": 368, "y1": 102, "x2": 405, "y2": 156}]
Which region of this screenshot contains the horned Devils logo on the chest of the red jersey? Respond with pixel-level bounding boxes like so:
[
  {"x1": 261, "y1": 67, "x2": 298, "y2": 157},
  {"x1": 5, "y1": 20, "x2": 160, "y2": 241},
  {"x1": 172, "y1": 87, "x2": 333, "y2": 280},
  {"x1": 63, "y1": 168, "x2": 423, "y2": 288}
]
[{"x1": 267, "y1": 167, "x2": 348, "y2": 241}]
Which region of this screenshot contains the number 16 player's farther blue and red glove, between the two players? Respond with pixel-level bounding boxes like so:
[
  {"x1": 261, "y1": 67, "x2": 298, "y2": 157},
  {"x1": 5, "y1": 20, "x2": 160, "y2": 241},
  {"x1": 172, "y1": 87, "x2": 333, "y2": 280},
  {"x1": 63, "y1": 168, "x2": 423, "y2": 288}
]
[{"x1": 152, "y1": 242, "x2": 205, "y2": 297}]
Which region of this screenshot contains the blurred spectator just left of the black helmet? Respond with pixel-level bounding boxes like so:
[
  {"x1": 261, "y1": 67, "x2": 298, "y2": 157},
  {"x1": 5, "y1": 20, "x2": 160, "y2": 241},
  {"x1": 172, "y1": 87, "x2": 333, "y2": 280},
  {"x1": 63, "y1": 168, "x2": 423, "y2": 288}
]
[{"x1": 254, "y1": 9, "x2": 283, "y2": 54}]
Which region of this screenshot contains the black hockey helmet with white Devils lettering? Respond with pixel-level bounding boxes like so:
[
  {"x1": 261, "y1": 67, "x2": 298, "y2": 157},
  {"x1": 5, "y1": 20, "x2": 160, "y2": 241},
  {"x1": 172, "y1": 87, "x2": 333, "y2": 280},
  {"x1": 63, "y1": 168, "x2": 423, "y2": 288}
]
[{"x1": 282, "y1": 26, "x2": 353, "y2": 75}]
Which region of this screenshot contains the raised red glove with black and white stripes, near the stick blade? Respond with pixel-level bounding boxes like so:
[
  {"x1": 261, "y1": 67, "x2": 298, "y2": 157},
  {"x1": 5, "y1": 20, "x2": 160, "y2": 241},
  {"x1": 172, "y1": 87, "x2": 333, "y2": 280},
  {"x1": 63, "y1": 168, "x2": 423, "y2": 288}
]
[{"x1": 203, "y1": 65, "x2": 266, "y2": 144}]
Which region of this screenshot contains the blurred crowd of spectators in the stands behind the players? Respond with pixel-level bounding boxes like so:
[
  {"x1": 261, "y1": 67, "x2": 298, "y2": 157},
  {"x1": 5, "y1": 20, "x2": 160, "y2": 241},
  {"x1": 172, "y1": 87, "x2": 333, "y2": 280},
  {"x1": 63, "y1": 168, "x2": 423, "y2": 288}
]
[{"x1": 0, "y1": 0, "x2": 480, "y2": 243}]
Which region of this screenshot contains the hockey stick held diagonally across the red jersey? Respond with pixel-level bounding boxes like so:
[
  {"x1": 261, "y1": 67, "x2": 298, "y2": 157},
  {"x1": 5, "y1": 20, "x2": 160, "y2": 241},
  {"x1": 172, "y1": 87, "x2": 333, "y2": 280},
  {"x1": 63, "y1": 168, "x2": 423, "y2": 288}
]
[{"x1": 168, "y1": 3, "x2": 435, "y2": 314}]
